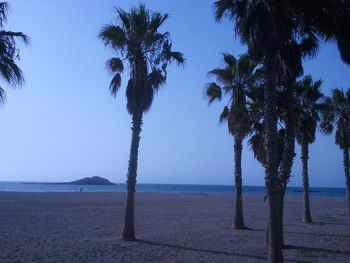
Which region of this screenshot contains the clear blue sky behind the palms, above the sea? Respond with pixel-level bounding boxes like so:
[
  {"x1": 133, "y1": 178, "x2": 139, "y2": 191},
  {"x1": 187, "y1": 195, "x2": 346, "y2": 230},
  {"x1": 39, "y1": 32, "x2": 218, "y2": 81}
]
[{"x1": 0, "y1": 0, "x2": 350, "y2": 187}]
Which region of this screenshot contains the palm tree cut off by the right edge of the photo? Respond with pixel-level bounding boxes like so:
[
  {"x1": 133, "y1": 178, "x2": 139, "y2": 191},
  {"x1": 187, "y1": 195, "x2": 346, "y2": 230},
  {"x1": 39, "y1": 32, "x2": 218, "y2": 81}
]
[{"x1": 321, "y1": 89, "x2": 350, "y2": 215}]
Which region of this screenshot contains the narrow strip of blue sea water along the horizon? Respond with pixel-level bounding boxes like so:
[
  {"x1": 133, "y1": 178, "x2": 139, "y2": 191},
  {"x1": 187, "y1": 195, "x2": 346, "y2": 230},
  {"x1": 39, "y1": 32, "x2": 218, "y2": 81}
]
[{"x1": 0, "y1": 182, "x2": 346, "y2": 196}]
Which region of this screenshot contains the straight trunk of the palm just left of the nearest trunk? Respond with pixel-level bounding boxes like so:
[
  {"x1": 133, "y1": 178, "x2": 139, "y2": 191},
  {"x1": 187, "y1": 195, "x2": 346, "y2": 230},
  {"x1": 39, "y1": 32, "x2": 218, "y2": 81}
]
[{"x1": 233, "y1": 137, "x2": 245, "y2": 229}]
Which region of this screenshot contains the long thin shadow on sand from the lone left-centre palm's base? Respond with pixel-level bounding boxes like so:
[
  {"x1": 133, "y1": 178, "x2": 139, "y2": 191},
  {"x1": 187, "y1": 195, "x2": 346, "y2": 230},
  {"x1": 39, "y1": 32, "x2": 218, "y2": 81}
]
[{"x1": 137, "y1": 240, "x2": 309, "y2": 263}]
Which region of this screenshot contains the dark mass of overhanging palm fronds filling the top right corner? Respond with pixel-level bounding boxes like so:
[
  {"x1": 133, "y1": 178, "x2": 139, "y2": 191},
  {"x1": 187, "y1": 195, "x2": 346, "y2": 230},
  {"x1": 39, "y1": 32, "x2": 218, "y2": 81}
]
[{"x1": 214, "y1": 0, "x2": 350, "y2": 80}]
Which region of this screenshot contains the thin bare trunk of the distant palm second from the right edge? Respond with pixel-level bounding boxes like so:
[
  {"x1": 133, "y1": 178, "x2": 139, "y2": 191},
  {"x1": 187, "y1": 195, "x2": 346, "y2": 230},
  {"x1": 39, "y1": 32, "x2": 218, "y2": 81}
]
[{"x1": 301, "y1": 137, "x2": 312, "y2": 223}]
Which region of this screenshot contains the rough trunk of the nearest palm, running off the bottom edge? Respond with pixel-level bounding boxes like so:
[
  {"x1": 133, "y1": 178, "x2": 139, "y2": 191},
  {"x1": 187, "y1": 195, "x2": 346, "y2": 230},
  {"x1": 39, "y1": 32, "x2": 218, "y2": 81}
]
[{"x1": 264, "y1": 55, "x2": 283, "y2": 263}]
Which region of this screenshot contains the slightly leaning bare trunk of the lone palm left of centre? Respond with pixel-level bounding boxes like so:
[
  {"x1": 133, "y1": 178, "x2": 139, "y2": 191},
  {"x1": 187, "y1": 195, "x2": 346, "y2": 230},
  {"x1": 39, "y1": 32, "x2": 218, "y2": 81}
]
[{"x1": 122, "y1": 113, "x2": 142, "y2": 241}]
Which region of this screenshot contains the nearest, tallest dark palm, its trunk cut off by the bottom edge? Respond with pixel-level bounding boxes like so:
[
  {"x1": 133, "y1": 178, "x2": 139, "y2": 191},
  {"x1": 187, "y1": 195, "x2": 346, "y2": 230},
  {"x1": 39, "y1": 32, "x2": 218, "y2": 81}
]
[{"x1": 215, "y1": 0, "x2": 308, "y2": 262}]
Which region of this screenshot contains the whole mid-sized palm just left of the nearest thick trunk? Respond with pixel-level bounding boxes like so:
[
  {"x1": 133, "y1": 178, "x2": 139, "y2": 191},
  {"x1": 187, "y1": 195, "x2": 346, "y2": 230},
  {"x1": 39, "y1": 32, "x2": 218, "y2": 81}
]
[{"x1": 205, "y1": 53, "x2": 257, "y2": 229}]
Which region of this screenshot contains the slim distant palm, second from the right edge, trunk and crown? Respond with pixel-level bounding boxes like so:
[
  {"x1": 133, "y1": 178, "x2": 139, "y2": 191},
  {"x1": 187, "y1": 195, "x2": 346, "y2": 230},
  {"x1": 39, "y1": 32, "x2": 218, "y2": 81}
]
[{"x1": 295, "y1": 76, "x2": 324, "y2": 223}]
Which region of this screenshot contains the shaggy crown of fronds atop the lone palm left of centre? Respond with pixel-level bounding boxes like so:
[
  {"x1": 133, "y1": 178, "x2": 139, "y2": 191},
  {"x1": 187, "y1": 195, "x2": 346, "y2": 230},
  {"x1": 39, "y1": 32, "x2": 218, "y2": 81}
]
[{"x1": 99, "y1": 5, "x2": 184, "y2": 114}]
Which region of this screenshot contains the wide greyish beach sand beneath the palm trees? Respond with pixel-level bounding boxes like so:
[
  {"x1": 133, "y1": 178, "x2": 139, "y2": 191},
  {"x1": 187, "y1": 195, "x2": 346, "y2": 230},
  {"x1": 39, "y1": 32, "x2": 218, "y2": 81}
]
[{"x1": 0, "y1": 193, "x2": 350, "y2": 263}]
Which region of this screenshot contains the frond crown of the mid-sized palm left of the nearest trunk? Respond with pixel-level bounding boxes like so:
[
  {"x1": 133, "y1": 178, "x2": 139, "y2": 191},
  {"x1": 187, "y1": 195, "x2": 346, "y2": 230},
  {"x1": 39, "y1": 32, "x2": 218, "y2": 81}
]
[{"x1": 205, "y1": 53, "x2": 258, "y2": 139}]
